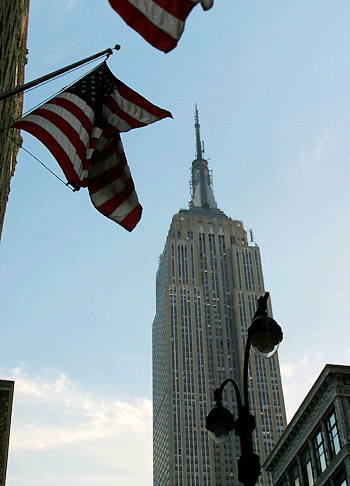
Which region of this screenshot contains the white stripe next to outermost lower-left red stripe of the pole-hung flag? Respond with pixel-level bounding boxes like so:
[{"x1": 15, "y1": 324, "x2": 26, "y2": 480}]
[{"x1": 23, "y1": 114, "x2": 87, "y2": 181}]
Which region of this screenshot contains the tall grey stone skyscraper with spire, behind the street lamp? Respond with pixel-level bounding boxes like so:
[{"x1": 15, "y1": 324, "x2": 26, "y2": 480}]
[{"x1": 152, "y1": 109, "x2": 286, "y2": 486}]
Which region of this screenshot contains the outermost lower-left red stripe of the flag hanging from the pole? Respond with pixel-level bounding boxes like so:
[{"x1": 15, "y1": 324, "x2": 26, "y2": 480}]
[{"x1": 14, "y1": 120, "x2": 87, "y2": 187}]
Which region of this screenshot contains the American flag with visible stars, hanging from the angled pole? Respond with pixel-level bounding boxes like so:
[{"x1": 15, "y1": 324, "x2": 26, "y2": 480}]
[{"x1": 13, "y1": 62, "x2": 172, "y2": 231}]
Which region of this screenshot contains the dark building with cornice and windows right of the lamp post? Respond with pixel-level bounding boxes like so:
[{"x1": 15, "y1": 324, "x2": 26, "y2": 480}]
[{"x1": 264, "y1": 364, "x2": 350, "y2": 486}]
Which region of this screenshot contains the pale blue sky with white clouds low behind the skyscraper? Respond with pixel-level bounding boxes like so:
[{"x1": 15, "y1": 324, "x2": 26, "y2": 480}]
[{"x1": 0, "y1": 0, "x2": 350, "y2": 486}]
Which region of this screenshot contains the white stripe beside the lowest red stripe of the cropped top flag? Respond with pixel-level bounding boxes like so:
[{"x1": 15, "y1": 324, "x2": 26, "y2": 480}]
[{"x1": 129, "y1": 0, "x2": 185, "y2": 40}]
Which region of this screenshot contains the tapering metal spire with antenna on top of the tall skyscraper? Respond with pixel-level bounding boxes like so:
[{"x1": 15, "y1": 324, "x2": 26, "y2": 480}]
[{"x1": 190, "y1": 104, "x2": 218, "y2": 209}]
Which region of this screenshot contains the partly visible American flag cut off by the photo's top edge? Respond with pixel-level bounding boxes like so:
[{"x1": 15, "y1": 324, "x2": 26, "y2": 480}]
[{"x1": 109, "y1": 0, "x2": 214, "y2": 52}]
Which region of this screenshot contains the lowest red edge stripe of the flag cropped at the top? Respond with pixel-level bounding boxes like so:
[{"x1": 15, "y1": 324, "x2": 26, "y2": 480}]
[{"x1": 109, "y1": 0, "x2": 183, "y2": 52}]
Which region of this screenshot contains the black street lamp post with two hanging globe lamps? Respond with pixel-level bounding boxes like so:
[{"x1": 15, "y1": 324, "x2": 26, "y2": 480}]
[{"x1": 206, "y1": 292, "x2": 283, "y2": 486}]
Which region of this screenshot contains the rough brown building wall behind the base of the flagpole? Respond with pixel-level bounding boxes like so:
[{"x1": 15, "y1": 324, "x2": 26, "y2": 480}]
[{"x1": 0, "y1": 0, "x2": 29, "y2": 238}]
